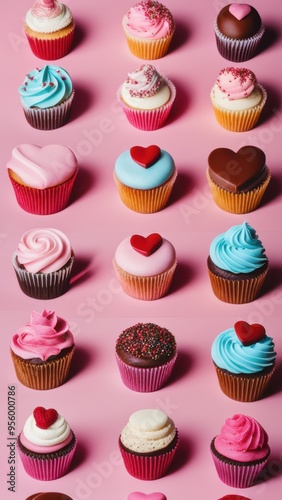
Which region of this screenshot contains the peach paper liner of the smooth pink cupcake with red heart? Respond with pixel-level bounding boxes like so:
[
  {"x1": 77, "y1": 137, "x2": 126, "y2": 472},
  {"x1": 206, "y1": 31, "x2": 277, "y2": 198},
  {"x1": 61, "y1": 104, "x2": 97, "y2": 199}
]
[{"x1": 113, "y1": 260, "x2": 177, "y2": 300}]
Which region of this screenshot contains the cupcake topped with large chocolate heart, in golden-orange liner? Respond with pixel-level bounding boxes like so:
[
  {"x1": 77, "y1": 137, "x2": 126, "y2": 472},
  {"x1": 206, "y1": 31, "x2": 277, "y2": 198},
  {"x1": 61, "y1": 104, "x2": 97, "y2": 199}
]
[{"x1": 207, "y1": 146, "x2": 271, "y2": 214}]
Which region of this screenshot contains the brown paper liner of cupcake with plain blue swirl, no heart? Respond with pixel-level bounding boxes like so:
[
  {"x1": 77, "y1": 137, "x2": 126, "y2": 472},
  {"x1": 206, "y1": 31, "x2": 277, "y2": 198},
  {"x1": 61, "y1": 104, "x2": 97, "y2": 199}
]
[{"x1": 208, "y1": 267, "x2": 269, "y2": 304}]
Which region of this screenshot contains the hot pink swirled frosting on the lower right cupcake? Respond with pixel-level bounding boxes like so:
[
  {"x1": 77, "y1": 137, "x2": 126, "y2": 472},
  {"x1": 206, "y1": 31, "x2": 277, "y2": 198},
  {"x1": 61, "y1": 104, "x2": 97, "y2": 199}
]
[{"x1": 214, "y1": 414, "x2": 269, "y2": 462}]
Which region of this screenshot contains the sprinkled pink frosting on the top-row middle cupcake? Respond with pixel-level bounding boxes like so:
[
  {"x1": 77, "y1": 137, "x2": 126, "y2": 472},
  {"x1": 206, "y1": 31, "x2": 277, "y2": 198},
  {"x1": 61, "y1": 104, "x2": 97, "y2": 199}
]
[{"x1": 124, "y1": 0, "x2": 174, "y2": 39}]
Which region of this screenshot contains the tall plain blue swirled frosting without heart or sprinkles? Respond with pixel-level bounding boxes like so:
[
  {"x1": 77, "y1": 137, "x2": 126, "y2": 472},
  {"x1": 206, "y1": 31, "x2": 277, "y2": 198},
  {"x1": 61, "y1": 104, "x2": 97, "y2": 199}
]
[{"x1": 210, "y1": 222, "x2": 268, "y2": 274}]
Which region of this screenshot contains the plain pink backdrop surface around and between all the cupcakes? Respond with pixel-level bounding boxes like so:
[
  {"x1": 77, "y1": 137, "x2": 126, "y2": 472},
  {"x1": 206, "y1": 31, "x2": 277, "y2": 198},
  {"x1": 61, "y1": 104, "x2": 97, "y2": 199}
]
[{"x1": 0, "y1": 0, "x2": 282, "y2": 500}]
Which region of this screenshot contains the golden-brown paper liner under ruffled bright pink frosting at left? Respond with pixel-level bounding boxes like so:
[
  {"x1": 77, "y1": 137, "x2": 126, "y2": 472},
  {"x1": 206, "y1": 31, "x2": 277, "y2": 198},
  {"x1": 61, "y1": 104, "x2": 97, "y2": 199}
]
[{"x1": 11, "y1": 346, "x2": 75, "y2": 390}]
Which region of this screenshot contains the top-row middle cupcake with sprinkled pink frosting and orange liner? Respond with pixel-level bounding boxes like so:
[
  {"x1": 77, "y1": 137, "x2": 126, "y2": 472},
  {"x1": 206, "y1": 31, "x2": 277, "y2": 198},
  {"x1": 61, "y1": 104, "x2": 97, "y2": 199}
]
[{"x1": 122, "y1": 0, "x2": 175, "y2": 60}]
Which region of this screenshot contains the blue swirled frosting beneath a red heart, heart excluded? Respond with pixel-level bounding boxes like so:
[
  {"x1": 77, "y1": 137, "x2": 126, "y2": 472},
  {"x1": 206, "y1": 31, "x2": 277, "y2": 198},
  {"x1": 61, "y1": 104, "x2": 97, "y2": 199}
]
[{"x1": 211, "y1": 328, "x2": 276, "y2": 374}]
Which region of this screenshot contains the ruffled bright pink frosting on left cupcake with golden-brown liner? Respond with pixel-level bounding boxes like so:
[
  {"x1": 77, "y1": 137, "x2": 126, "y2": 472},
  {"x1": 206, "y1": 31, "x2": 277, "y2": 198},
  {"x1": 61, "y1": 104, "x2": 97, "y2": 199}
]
[{"x1": 11, "y1": 309, "x2": 74, "y2": 361}]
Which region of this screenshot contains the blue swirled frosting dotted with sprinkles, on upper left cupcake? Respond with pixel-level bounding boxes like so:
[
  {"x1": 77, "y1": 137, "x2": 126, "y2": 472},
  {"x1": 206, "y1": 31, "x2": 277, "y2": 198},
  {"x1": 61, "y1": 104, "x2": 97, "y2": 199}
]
[{"x1": 18, "y1": 64, "x2": 73, "y2": 109}]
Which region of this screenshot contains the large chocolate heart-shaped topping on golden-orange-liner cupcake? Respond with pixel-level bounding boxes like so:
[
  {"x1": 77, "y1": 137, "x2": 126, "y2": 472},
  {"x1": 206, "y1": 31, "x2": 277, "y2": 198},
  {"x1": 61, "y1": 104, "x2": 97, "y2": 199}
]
[{"x1": 208, "y1": 146, "x2": 266, "y2": 193}]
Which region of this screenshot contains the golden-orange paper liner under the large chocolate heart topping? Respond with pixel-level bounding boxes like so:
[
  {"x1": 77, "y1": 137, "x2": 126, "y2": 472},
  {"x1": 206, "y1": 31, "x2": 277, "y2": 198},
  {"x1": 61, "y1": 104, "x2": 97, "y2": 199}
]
[{"x1": 207, "y1": 170, "x2": 271, "y2": 214}]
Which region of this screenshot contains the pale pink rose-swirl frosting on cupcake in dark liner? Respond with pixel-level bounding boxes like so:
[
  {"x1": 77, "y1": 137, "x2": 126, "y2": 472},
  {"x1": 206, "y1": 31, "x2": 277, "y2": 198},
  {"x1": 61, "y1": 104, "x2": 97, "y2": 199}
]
[{"x1": 16, "y1": 228, "x2": 72, "y2": 273}]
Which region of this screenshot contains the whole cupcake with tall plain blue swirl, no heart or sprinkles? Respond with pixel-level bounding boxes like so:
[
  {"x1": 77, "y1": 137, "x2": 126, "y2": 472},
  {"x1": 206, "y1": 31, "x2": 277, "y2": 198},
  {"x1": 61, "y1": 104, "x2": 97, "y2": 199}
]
[{"x1": 207, "y1": 222, "x2": 269, "y2": 304}]
